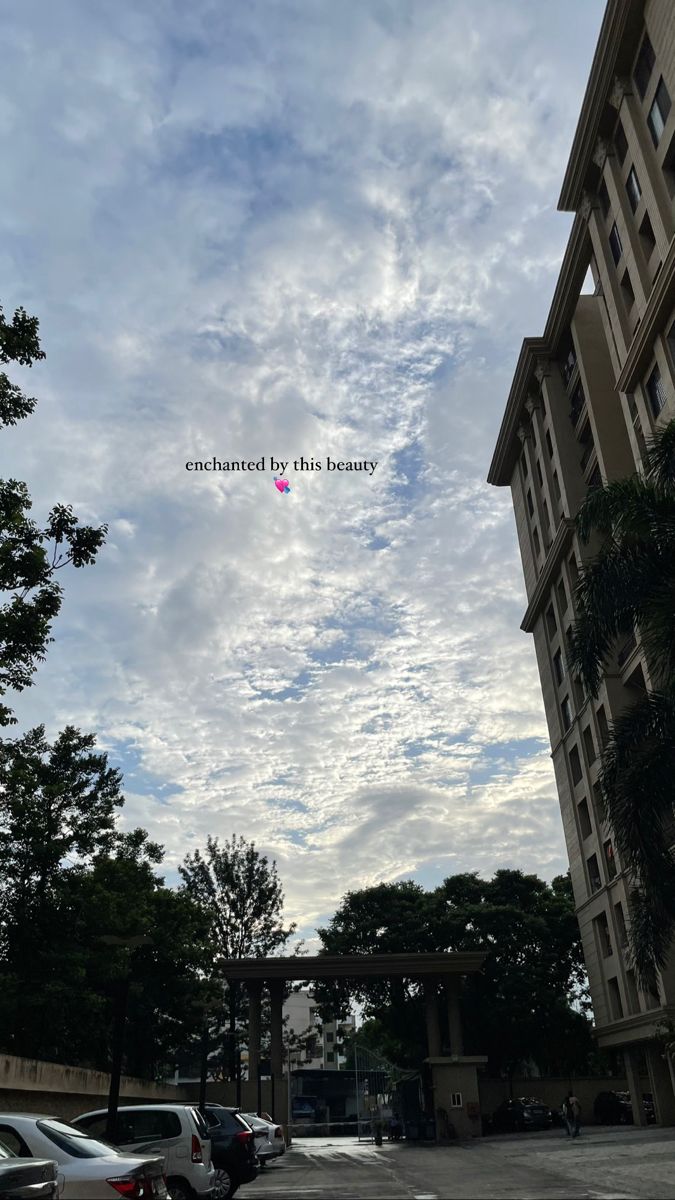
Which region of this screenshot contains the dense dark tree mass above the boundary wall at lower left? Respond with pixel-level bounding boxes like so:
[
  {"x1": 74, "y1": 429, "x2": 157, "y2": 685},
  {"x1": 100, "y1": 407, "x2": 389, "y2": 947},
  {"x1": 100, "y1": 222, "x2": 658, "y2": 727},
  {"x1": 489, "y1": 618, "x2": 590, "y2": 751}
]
[{"x1": 0, "y1": 727, "x2": 210, "y2": 1078}]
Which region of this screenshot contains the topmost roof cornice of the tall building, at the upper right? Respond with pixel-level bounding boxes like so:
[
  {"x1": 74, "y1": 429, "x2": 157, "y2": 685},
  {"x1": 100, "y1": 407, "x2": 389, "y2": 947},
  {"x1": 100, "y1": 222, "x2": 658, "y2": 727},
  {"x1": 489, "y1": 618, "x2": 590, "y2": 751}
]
[{"x1": 557, "y1": 0, "x2": 644, "y2": 212}]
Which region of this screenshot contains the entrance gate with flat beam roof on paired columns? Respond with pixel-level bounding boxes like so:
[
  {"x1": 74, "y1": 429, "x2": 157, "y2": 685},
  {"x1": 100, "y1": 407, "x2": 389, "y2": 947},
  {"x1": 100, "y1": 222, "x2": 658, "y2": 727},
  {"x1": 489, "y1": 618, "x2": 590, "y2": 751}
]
[{"x1": 223, "y1": 952, "x2": 488, "y2": 1138}]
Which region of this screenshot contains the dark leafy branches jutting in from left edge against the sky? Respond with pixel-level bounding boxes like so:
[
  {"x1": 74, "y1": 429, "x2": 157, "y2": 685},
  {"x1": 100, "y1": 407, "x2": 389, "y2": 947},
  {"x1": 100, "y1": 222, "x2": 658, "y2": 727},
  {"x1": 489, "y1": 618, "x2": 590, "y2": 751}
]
[{"x1": 0, "y1": 308, "x2": 107, "y2": 726}]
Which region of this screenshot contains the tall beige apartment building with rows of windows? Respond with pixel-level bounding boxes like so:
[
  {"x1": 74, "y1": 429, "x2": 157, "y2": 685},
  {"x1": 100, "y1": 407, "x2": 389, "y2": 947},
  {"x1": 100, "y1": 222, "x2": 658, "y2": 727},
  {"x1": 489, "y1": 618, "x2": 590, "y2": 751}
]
[{"x1": 489, "y1": 0, "x2": 675, "y2": 1124}]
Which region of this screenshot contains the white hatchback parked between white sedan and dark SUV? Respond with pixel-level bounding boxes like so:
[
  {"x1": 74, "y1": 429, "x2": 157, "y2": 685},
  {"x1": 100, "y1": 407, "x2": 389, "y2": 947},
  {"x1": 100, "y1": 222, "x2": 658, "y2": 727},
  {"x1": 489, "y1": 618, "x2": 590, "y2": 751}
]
[{"x1": 74, "y1": 1104, "x2": 215, "y2": 1200}]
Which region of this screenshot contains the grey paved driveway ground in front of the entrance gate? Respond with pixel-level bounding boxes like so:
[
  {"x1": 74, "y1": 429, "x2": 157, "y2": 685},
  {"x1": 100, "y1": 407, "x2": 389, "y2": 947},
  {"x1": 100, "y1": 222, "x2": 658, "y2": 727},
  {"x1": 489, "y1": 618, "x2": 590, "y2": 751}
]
[{"x1": 239, "y1": 1127, "x2": 675, "y2": 1200}]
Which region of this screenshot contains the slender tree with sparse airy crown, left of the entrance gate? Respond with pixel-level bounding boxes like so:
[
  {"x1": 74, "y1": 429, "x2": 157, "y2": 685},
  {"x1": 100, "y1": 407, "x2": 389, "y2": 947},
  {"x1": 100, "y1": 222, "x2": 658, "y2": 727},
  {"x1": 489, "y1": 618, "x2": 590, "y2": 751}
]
[{"x1": 179, "y1": 835, "x2": 295, "y2": 1079}]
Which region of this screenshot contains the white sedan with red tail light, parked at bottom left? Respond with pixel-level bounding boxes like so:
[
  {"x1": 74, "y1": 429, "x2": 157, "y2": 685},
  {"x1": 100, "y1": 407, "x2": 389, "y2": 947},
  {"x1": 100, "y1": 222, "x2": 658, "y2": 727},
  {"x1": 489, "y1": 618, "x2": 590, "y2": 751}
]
[{"x1": 0, "y1": 1112, "x2": 168, "y2": 1200}]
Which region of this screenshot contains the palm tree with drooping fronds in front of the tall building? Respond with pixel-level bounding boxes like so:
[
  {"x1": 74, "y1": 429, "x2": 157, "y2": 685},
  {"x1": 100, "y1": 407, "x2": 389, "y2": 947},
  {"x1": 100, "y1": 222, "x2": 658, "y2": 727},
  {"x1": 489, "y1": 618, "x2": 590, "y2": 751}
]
[{"x1": 571, "y1": 421, "x2": 675, "y2": 990}]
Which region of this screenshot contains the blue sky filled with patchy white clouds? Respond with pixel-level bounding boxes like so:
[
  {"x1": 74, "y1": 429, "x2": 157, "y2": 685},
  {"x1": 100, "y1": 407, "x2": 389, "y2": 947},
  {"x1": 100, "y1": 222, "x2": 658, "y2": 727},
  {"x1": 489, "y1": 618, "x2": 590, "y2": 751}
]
[{"x1": 0, "y1": 0, "x2": 604, "y2": 947}]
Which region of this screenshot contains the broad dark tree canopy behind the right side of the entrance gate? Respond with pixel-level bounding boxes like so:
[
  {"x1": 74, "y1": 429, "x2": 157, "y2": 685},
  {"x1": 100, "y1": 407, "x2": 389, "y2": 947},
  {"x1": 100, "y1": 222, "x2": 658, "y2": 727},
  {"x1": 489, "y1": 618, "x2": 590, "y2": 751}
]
[{"x1": 317, "y1": 871, "x2": 592, "y2": 1074}]
